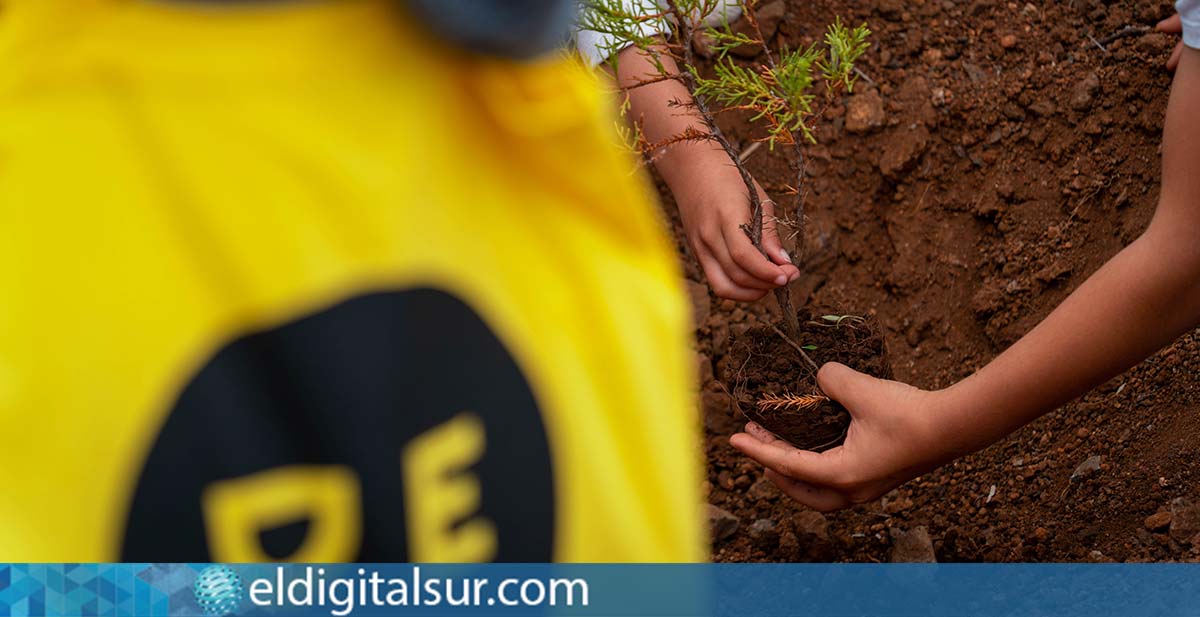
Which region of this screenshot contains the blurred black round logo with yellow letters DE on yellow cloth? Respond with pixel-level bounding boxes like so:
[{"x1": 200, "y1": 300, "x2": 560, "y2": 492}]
[{"x1": 121, "y1": 288, "x2": 554, "y2": 562}]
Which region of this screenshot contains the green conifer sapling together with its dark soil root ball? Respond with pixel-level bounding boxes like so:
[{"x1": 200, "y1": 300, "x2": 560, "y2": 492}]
[{"x1": 581, "y1": 0, "x2": 890, "y2": 449}]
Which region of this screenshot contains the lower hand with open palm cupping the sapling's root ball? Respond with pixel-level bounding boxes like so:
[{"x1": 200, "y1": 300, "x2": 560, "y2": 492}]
[{"x1": 730, "y1": 363, "x2": 953, "y2": 511}]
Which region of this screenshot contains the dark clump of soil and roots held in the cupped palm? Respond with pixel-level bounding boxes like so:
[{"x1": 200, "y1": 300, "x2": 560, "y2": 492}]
[{"x1": 724, "y1": 311, "x2": 892, "y2": 451}]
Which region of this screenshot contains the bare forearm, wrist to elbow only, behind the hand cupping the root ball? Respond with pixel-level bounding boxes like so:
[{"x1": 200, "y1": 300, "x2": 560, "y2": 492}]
[{"x1": 938, "y1": 226, "x2": 1200, "y2": 454}]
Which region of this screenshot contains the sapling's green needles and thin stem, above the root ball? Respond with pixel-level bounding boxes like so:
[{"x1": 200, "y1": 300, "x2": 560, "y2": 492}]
[{"x1": 582, "y1": 0, "x2": 870, "y2": 340}]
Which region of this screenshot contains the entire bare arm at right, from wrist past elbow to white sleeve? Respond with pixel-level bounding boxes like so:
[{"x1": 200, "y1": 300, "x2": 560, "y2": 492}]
[{"x1": 931, "y1": 50, "x2": 1200, "y2": 454}]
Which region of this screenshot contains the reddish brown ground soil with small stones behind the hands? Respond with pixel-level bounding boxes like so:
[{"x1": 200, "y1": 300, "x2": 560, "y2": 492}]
[{"x1": 666, "y1": 0, "x2": 1200, "y2": 562}]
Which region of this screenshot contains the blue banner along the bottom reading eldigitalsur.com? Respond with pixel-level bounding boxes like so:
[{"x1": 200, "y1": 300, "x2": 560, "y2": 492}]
[{"x1": 0, "y1": 563, "x2": 1200, "y2": 617}]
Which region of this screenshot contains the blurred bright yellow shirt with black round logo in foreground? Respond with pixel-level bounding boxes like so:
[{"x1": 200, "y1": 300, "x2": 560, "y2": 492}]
[{"x1": 0, "y1": 0, "x2": 704, "y2": 562}]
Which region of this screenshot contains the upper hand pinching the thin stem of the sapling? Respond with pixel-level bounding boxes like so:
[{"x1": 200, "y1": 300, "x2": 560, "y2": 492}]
[{"x1": 671, "y1": 152, "x2": 800, "y2": 301}]
